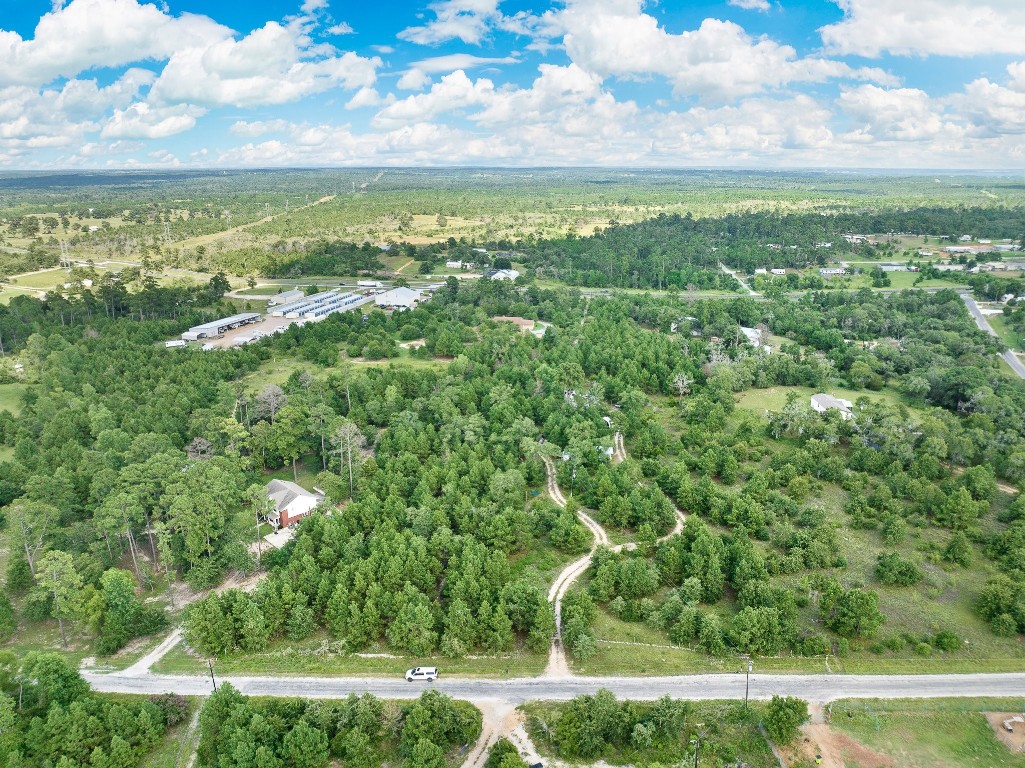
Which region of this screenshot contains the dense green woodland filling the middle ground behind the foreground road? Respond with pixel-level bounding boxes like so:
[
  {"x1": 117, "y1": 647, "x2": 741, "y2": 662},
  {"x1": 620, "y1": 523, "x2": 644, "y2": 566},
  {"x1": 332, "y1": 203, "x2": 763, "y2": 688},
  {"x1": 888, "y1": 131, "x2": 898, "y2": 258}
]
[{"x1": 0, "y1": 262, "x2": 1025, "y2": 676}]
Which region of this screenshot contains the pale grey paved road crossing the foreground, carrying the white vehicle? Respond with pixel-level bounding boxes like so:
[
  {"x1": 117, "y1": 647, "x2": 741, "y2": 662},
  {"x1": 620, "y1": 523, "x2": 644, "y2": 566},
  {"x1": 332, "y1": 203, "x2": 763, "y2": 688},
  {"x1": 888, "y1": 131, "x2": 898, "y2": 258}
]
[{"x1": 83, "y1": 673, "x2": 1025, "y2": 704}]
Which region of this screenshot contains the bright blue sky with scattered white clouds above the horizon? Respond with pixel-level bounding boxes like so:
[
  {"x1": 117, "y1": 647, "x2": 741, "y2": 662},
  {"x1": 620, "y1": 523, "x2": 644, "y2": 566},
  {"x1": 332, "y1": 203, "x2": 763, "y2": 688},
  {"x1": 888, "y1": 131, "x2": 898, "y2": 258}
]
[{"x1": 0, "y1": 0, "x2": 1025, "y2": 169}]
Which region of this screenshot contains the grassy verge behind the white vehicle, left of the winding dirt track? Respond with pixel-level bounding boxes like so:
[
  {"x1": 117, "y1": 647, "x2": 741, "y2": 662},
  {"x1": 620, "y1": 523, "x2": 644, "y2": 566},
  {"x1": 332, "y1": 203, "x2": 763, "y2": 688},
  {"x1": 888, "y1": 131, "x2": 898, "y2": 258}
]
[{"x1": 154, "y1": 633, "x2": 547, "y2": 672}]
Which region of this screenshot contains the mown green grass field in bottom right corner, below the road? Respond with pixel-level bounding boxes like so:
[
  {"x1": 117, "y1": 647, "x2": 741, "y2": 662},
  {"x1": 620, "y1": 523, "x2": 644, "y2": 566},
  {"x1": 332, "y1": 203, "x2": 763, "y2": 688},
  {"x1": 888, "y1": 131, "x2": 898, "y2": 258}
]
[{"x1": 830, "y1": 696, "x2": 1025, "y2": 768}]
